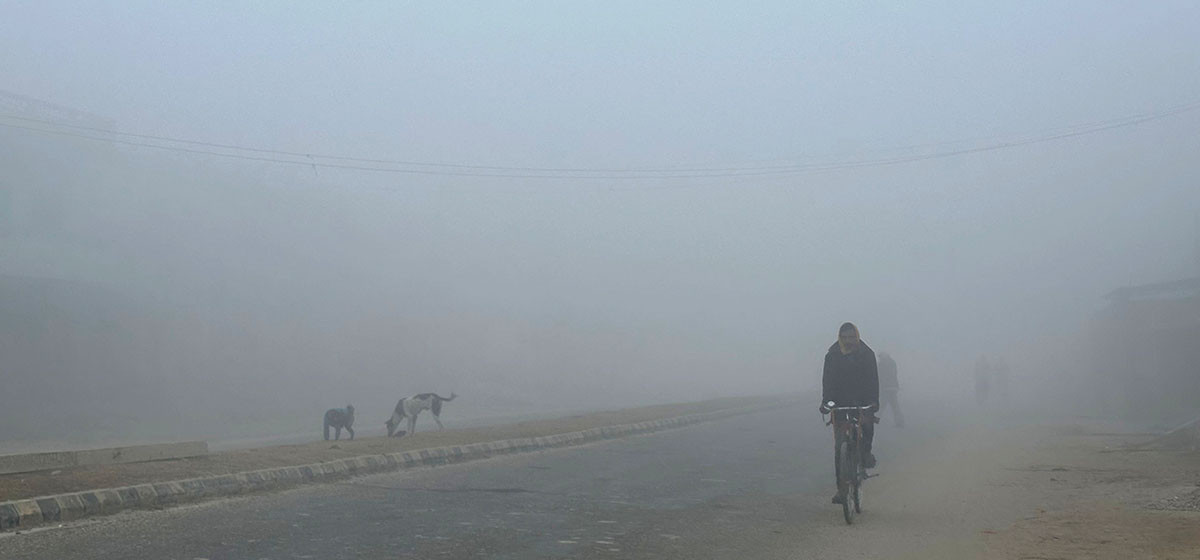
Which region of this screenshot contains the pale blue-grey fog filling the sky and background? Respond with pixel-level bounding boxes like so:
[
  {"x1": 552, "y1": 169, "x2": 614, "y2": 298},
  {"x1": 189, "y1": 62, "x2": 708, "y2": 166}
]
[{"x1": 0, "y1": 1, "x2": 1200, "y2": 450}]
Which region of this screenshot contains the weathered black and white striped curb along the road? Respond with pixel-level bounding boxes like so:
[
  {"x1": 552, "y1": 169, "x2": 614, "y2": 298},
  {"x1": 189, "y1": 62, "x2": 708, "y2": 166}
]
[{"x1": 0, "y1": 401, "x2": 792, "y2": 531}]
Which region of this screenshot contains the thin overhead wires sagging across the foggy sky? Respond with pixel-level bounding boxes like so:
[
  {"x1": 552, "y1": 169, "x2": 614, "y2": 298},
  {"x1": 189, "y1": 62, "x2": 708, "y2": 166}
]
[{"x1": 0, "y1": 102, "x2": 1200, "y2": 180}]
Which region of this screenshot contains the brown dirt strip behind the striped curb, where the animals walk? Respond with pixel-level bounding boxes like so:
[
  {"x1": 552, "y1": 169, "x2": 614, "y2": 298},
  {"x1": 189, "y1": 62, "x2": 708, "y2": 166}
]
[{"x1": 0, "y1": 397, "x2": 770, "y2": 501}]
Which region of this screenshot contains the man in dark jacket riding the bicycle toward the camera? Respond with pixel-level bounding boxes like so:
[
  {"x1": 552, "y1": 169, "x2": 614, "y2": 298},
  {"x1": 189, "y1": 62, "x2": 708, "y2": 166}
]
[{"x1": 821, "y1": 323, "x2": 880, "y2": 504}]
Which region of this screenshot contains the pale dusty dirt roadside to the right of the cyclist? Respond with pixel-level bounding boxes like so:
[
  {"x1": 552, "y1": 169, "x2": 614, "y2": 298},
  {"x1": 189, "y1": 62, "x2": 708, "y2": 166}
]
[{"x1": 809, "y1": 421, "x2": 1200, "y2": 560}]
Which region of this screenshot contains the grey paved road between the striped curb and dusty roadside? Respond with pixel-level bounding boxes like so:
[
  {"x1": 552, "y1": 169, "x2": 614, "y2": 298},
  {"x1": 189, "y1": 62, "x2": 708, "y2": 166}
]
[{"x1": 0, "y1": 407, "x2": 928, "y2": 560}]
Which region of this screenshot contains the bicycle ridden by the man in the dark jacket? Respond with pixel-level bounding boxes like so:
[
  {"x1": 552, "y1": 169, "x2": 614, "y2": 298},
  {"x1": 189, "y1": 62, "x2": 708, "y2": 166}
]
[{"x1": 821, "y1": 401, "x2": 878, "y2": 525}]
